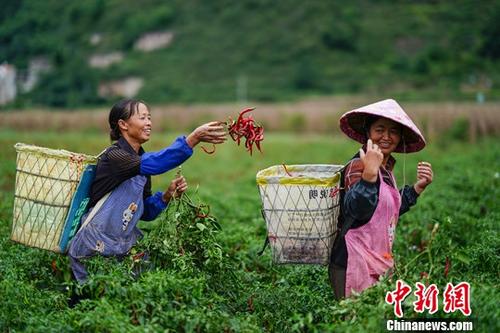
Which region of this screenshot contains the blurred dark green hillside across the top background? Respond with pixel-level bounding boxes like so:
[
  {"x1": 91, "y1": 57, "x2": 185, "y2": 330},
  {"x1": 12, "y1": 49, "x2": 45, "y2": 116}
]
[{"x1": 0, "y1": 0, "x2": 500, "y2": 107}]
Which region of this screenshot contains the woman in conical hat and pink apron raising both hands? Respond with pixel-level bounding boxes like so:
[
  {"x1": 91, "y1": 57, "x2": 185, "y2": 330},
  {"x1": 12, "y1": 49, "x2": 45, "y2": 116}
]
[{"x1": 329, "y1": 99, "x2": 433, "y2": 298}]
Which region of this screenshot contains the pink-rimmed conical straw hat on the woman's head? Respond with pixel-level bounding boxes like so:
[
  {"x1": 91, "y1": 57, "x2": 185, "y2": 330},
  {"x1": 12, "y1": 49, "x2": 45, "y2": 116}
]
[{"x1": 340, "y1": 99, "x2": 425, "y2": 153}]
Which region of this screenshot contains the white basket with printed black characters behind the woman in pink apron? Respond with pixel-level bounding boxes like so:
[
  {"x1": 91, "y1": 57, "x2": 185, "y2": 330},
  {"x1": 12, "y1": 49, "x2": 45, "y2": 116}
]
[{"x1": 256, "y1": 164, "x2": 342, "y2": 265}]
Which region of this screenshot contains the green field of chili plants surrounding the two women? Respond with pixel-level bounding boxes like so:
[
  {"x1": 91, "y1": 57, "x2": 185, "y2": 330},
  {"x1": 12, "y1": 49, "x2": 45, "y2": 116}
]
[{"x1": 0, "y1": 129, "x2": 500, "y2": 332}]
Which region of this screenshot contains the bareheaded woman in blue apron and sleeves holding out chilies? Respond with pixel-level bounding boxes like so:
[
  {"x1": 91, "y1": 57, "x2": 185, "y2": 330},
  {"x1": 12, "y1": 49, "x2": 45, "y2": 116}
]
[{"x1": 68, "y1": 99, "x2": 226, "y2": 282}]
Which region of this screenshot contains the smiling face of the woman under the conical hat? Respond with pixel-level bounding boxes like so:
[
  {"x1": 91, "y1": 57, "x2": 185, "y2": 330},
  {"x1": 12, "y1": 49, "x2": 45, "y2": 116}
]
[{"x1": 368, "y1": 117, "x2": 402, "y2": 156}]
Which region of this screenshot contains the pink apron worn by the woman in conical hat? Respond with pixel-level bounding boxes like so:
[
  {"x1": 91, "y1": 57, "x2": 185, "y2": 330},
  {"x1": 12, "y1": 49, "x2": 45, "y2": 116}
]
[{"x1": 345, "y1": 171, "x2": 401, "y2": 297}]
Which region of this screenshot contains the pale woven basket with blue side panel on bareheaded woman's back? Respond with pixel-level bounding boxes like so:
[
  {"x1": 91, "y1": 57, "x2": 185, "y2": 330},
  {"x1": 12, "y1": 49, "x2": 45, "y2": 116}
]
[{"x1": 11, "y1": 143, "x2": 96, "y2": 253}]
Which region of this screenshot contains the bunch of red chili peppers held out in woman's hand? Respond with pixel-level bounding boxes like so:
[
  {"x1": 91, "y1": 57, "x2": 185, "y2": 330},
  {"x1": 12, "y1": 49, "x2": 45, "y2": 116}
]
[{"x1": 227, "y1": 108, "x2": 264, "y2": 155}]
